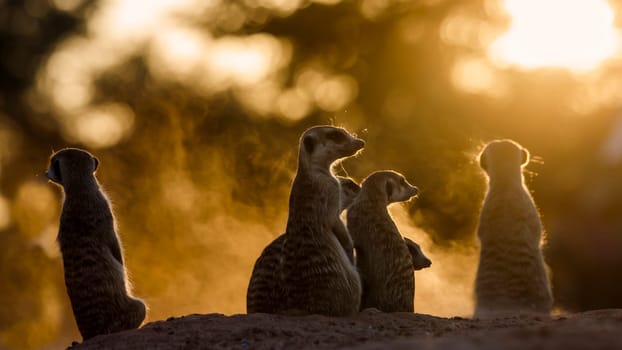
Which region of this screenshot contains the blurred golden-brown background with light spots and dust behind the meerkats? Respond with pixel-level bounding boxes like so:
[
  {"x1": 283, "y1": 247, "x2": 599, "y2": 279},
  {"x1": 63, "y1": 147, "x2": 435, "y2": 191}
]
[{"x1": 0, "y1": 0, "x2": 622, "y2": 349}]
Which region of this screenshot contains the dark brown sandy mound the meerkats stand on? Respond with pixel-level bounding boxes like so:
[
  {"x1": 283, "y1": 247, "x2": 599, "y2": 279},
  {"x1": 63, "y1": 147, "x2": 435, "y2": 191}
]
[{"x1": 72, "y1": 309, "x2": 622, "y2": 350}]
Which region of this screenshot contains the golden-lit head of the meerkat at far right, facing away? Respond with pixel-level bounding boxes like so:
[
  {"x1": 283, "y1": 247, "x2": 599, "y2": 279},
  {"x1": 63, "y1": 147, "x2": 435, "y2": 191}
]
[{"x1": 479, "y1": 140, "x2": 529, "y2": 176}]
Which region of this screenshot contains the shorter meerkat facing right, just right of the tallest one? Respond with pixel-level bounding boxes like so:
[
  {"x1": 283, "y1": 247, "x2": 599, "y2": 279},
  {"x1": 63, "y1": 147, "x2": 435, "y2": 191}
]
[{"x1": 347, "y1": 171, "x2": 429, "y2": 312}]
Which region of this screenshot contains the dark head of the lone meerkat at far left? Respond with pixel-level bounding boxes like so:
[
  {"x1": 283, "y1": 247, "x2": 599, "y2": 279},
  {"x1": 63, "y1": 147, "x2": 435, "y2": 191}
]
[{"x1": 45, "y1": 148, "x2": 99, "y2": 187}]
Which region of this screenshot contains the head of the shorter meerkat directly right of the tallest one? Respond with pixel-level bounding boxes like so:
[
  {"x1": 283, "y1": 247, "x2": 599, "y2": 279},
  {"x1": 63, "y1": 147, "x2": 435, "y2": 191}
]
[{"x1": 361, "y1": 170, "x2": 419, "y2": 205}]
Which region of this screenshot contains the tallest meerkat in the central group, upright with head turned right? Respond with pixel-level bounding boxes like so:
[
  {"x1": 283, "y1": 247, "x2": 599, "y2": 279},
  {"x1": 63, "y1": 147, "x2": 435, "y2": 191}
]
[{"x1": 279, "y1": 126, "x2": 365, "y2": 316}]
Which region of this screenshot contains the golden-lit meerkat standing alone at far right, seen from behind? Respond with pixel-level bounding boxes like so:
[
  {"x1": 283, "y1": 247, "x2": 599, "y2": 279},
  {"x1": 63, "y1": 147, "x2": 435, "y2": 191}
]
[{"x1": 475, "y1": 140, "x2": 552, "y2": 317}]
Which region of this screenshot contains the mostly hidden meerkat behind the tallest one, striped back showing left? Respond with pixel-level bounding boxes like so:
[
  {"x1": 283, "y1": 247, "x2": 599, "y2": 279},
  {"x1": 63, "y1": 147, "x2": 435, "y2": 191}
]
[{"x1": 246, "y1": 176, "x2": 361, "y2": 314}]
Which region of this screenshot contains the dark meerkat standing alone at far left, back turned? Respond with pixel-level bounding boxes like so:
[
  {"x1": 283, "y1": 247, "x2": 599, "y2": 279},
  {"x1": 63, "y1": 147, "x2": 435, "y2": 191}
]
[{"x1": 46, "y1": 148, "x2": 146, "y2": 340}]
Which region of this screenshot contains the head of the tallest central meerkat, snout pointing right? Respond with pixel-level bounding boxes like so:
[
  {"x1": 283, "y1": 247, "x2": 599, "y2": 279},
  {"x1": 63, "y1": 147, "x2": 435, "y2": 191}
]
[{"x1": 300, "y1": 126, "x2": 365, "y2": 168}]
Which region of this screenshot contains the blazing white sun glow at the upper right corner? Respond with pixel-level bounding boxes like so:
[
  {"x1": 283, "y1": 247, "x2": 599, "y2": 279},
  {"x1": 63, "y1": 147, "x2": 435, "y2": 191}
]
[{"x1": 489, "y1": 0, "x2": 619, "y2": 71}]
